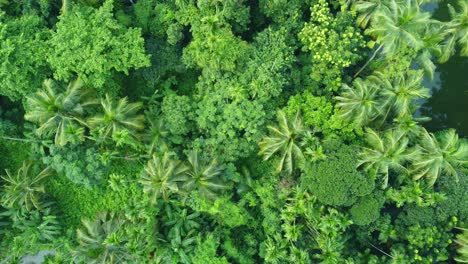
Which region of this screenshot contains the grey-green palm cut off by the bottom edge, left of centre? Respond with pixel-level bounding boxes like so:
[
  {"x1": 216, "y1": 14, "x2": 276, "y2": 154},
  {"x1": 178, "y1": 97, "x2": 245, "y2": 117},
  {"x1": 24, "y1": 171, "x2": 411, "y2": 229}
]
[{"x1": 72, "y1": 212, "x2": 131, "y2": 264}]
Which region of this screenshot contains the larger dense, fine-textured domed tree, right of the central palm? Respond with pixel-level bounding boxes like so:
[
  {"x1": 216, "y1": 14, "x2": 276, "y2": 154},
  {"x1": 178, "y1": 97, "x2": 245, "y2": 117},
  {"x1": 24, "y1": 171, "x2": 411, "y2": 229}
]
[{"x1": 301, "y1": 139, "x2": 374, "y2": 206}]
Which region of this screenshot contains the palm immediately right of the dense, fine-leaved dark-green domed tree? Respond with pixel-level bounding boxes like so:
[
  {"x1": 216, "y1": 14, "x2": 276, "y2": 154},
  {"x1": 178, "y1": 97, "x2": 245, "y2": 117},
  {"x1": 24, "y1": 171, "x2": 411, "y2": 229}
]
[{"x1": 357, "y1": 128, "x2": 410, "y2": 188}]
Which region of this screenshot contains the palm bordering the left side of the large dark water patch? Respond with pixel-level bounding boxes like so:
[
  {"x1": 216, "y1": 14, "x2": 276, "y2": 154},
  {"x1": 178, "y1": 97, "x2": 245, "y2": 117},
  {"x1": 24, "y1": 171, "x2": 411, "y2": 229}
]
[{"x1": 369, "y1": 71, "x2": 430, "y2": 120}]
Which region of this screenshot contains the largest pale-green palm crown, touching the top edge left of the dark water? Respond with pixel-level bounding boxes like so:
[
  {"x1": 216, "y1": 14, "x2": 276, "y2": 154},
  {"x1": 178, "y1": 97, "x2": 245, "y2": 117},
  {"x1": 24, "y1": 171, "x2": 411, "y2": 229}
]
[{"x1": 355, "y1": 0, "x2": 447, "y2": 79}]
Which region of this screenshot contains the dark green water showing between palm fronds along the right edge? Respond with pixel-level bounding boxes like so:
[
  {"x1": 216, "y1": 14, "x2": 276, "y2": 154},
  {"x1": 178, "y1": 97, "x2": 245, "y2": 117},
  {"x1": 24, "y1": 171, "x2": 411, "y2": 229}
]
[{"x1": 421, "y1": 0, "x2": 468, "y2": 137}]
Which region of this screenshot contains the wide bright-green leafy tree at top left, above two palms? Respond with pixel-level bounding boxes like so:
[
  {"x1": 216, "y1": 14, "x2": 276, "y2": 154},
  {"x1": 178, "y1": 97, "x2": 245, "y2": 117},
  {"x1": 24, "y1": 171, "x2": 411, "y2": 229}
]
[{"x1": 47, "y1": 0, "x2": 149, "y2": 93}]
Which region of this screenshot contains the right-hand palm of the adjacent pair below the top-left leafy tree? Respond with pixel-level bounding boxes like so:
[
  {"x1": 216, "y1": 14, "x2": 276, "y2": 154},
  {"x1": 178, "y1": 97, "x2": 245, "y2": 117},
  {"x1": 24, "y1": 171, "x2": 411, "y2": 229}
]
[{"x1": 88, "y1": 95, "x2": 144, "y2": 142}]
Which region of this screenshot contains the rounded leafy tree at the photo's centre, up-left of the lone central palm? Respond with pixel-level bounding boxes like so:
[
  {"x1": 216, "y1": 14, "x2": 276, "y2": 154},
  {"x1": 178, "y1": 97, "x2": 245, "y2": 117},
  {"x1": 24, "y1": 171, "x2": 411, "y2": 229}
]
[{"x1": 193, "y1": 79, "x2": 267, "y2": 162}]
